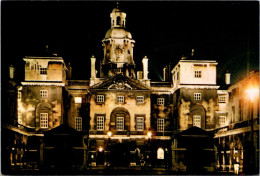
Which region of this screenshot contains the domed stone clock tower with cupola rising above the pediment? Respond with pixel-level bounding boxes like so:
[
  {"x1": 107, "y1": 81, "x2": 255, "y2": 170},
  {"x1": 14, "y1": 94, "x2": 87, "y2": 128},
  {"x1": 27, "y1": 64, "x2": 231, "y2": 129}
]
[{"x1": 101, "y1": 7, "x2": 135, "y2": 78}]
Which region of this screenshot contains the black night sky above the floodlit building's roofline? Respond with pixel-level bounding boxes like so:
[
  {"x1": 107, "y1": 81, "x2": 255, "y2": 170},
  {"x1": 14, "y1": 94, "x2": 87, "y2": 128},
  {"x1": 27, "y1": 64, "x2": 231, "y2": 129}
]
[{"x1": 1, "y1": 1, "x2": 259, "y2": 82}]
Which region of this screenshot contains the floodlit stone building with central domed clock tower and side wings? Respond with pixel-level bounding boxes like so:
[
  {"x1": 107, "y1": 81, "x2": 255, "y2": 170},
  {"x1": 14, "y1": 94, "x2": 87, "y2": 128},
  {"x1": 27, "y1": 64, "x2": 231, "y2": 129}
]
[{"x1": 2, "y1": 4, "x2": 259, "y2": 173}]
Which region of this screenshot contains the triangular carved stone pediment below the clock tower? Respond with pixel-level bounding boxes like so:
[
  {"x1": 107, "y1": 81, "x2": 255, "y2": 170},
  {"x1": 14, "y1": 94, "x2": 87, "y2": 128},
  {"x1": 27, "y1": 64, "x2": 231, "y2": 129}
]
[{"x1": 90, "y1": 74, "x2": 150, "y2": 91}]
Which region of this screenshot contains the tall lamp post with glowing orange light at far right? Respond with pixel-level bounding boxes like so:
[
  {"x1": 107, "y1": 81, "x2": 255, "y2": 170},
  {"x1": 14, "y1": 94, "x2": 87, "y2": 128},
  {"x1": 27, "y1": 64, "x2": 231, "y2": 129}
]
[{"x1": 246, "y1": 87, "x2": 259, "y2": 172}]
